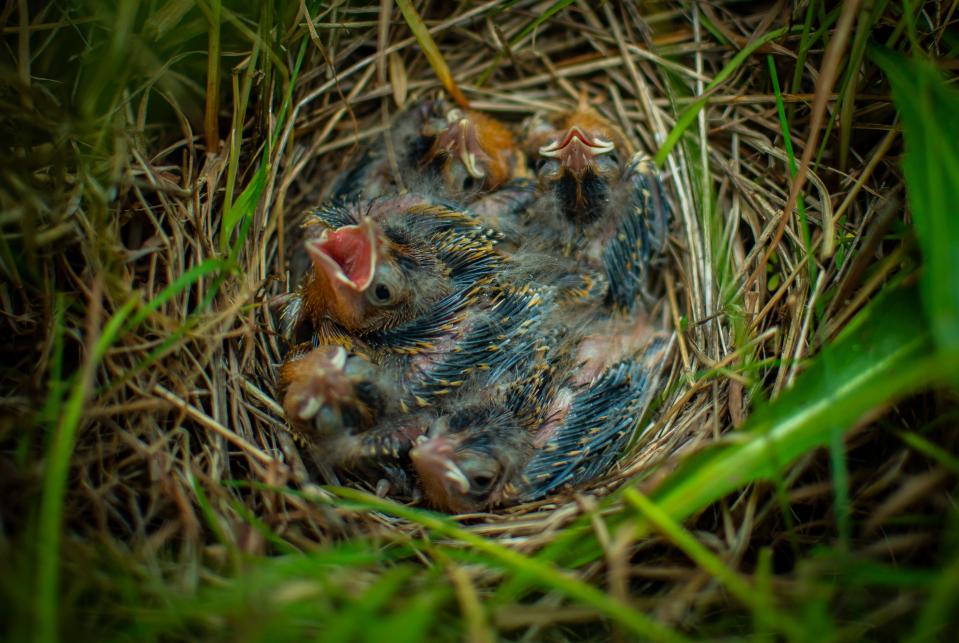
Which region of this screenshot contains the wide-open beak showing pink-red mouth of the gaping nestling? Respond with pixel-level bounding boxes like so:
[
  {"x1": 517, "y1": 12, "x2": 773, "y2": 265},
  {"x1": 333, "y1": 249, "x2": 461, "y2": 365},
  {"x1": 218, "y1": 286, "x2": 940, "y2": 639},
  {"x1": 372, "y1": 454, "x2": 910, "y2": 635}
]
[{"x1": 306, "y1": 218, "x2": 377, "y2": 293}]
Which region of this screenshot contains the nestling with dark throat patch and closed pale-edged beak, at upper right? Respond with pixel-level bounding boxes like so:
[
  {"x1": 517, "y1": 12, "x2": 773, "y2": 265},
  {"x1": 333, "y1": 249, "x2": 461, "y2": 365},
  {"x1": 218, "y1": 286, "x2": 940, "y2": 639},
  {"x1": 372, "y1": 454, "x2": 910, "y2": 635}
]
[{"x1": 526, "y1": 100, "x2": 672, "y2": 311}]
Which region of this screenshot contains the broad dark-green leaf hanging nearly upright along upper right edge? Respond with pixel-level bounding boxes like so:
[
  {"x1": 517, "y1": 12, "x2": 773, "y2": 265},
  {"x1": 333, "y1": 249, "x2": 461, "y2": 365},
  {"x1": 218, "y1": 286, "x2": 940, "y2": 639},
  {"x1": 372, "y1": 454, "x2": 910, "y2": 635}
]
[{"x1": 872, "y1": 49, "x2": 959, "y2": 360}]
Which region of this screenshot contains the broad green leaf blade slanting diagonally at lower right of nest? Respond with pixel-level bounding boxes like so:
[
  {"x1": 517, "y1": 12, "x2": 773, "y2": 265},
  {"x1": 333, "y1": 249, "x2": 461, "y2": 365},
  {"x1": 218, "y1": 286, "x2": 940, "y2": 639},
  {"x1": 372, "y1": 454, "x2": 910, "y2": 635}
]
[{"x1": 653, "y1": 288, "x2": 956, "y2": 518}]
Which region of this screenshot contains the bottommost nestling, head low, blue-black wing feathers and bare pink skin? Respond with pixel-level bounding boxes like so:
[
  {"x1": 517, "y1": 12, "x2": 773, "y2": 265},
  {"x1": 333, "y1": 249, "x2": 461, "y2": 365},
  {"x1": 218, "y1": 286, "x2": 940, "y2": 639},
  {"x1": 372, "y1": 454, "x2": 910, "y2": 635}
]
[{"x1": 410, "y1": 312, "x2": 666, "y2": 513}]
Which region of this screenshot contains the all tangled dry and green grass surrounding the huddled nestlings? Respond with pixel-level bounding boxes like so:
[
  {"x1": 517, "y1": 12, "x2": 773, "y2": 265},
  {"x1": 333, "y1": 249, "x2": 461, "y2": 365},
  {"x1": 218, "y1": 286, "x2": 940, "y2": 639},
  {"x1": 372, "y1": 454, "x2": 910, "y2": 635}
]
[{"x1": 0, "y1": 0, "x2": 959, "y2": 641}]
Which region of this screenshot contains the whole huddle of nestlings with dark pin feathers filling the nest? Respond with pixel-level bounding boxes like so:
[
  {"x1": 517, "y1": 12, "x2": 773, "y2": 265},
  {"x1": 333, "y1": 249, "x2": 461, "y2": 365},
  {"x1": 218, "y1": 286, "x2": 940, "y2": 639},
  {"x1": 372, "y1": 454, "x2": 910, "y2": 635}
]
[{"x1": 279, "y1": 99, "x2": 672, "y2": 513}]
